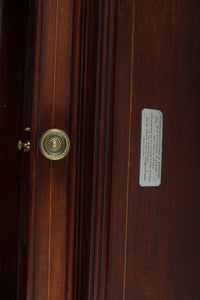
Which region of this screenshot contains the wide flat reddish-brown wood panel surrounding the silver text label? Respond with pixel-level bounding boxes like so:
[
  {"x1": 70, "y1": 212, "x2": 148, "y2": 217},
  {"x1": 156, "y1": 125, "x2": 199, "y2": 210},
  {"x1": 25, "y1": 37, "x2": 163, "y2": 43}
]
[{"x1": 107, "y1": 1, "x2": 200, "y2": 299}]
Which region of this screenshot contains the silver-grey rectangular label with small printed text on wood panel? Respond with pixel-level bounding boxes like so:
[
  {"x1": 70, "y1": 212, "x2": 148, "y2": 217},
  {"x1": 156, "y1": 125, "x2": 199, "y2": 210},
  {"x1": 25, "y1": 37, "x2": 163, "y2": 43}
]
[{"x1": 139, "y1": 108, "x2": 163, "y2": 187}]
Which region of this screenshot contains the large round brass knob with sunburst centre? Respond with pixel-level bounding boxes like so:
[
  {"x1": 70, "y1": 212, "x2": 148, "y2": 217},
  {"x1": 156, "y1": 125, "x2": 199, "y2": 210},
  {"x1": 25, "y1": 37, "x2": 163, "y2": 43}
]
[{"x1": 39, "y1": 128, "x2": 70, "y2": 160}]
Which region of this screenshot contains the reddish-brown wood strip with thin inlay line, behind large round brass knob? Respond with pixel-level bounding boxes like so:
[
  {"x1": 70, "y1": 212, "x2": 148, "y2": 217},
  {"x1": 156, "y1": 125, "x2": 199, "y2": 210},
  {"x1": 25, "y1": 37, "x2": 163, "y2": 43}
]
[{"x1": 27, "y1": 1, "x2": 78, "y2": 299}]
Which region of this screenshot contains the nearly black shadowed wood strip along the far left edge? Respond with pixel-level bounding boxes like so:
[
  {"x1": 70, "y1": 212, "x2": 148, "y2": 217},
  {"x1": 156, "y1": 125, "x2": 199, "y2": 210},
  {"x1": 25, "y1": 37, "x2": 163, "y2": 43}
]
[{"x1": 0, "y1": 0, "x2": 29, "y2": 300}]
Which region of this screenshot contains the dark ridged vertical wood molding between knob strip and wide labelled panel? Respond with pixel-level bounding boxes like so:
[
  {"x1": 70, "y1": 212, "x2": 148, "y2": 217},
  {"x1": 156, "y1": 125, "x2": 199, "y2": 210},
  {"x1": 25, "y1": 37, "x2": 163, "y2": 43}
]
[{"x1": 75, "y1": 0, "x2": 117, "y2": 299}]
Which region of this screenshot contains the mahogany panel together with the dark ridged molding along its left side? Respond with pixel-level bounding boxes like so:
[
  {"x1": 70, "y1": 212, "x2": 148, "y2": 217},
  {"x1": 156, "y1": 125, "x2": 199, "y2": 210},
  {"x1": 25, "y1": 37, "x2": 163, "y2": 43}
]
[{"x1": 75, "y1": 0, "x2": 200, "y2": 300}]
